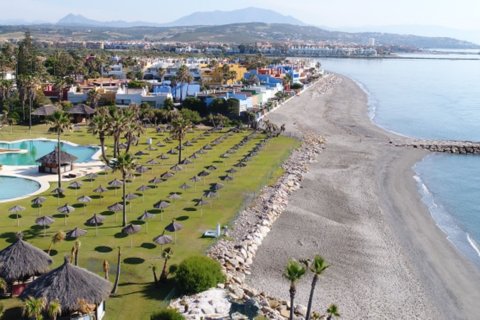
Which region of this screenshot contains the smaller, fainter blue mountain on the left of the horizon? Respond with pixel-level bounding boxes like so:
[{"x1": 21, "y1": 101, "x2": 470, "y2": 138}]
[{"x1": 57, "y1": 13, "x2": 161, "y2": 28}]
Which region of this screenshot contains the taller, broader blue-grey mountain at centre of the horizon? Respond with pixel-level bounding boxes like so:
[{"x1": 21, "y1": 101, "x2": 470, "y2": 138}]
[{"x1": 165, "y1": 7, "x2": 305, "y2": 26}]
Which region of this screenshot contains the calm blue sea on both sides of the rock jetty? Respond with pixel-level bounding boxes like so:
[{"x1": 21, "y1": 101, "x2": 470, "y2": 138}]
[{"x1": 321, "y1": 53, "x2": 480, "y2": 266}]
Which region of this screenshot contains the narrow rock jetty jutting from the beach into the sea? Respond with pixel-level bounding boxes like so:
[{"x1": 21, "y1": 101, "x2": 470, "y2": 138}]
[{"x1": 390, "y1": 140, "x2": 480, "y2": 154}]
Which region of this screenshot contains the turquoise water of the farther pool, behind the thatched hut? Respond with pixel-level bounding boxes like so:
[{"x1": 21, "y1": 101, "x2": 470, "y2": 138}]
[{"x1": 0, "y1": 140, "x2": 98, "y2": 166}]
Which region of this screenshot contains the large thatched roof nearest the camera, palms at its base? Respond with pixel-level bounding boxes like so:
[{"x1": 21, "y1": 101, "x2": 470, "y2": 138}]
[{"x1": 20, "y1": 257, "x2": 112, "y2": 313}]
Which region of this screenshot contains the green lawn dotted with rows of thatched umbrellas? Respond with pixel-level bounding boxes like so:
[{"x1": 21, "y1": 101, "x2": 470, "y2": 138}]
[{"x1": 0, "y1": 126, "x2": 299, "y2": 320}]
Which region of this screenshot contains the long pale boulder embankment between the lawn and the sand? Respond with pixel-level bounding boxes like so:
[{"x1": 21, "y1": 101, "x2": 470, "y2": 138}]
[{"x1": 171, "y1": 134, "x2": 324, "y2": 319}]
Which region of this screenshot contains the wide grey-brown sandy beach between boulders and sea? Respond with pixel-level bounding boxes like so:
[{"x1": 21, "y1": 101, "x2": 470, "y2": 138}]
[{"x1": 247, "y1": 77, "x2": 480, "y2": 319}]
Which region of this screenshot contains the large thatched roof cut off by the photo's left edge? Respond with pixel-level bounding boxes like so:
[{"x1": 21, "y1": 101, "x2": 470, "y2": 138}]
[{"x1": 0, "y1": 234, "x2": 52, "y2": 283}]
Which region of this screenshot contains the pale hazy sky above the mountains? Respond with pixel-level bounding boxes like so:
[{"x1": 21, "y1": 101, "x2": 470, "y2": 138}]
[{"x1": 0, "y1": 0, "x2": 480, "y2": 30}]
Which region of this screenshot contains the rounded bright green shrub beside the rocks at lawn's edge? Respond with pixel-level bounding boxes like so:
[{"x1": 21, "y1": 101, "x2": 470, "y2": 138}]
[{"x1": 175, "y1": 256, "x2": 225, "y2": 294}]
